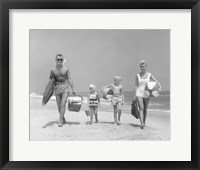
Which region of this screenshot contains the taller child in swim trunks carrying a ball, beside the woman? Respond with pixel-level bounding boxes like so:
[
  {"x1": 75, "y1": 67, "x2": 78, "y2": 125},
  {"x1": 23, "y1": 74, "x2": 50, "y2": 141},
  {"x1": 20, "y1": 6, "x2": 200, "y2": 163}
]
[{"x1": 106, "y1": 76, "x2": 124, "y2": 125}]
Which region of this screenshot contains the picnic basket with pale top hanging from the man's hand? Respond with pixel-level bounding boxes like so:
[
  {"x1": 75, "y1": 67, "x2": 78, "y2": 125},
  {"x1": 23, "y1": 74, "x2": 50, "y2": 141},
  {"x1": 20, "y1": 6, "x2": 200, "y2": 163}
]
[{"x1": 68, "y1": 93, "x2": 82, "y2": 112}]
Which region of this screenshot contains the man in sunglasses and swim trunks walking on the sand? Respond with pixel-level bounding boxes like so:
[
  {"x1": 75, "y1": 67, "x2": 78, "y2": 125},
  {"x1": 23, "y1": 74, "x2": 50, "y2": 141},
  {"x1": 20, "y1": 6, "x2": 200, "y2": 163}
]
[{"x1": 49, "y1": 54, "x2": 75, "y2": 127}]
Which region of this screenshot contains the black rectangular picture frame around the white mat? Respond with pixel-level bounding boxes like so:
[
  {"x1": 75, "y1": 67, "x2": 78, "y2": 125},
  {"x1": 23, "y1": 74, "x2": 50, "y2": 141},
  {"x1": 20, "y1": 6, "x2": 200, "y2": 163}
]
[{"x1": 0, "y1": 0, "x2": 200, "y2": 169}]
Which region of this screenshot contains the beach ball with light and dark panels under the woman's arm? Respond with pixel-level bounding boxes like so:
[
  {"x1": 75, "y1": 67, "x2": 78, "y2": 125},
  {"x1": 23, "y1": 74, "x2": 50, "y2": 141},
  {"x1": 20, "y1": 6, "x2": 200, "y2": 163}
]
[{"x1": 144, "y1": 81, "x2": 160, "y2": 97}]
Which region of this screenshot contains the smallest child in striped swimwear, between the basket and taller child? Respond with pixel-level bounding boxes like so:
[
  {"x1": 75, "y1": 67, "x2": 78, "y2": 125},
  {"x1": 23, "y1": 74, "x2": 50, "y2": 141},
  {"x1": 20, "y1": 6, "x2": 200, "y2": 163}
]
[{"x1": 88, "y1": 84, "x2": 100, "y2": 124}]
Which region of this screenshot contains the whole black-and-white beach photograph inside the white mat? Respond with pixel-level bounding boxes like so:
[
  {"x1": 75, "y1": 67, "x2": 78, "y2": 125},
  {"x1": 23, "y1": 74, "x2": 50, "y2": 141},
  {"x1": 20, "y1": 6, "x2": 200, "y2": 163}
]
[{"x1": 29, "y1": 29, "x2": 171, "y2": 141}]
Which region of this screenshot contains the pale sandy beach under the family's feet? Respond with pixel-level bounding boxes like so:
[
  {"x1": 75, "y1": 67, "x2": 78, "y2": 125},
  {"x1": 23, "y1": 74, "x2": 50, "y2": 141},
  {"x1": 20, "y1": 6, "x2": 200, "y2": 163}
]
[{"x1": 30, "y1": 99, "x2": 171, "y2": 141}]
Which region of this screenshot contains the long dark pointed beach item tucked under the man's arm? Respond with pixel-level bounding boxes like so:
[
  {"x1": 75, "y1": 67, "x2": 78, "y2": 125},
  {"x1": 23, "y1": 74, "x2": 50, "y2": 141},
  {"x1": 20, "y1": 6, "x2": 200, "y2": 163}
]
[{"x1": 42, "y1": 78, "x2": 55, "y2": 106}]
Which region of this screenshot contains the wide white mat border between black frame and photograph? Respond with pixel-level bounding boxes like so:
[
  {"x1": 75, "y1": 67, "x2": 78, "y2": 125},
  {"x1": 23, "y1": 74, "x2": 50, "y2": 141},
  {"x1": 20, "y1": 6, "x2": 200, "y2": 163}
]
[{"x1": 9, "y1": 9, "x2": 191, "y2": 161}]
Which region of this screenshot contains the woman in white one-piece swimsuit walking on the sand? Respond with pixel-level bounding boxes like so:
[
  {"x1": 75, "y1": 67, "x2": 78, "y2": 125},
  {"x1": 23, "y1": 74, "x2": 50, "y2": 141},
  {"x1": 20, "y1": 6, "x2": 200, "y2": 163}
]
[{"x1": 133, "y1": 60, "x2": 161, "y2": 129}]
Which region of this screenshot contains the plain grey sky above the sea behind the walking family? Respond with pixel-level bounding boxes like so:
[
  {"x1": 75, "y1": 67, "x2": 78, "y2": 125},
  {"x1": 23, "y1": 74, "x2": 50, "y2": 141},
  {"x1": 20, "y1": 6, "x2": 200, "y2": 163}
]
[{"x1": 29, "y1": 29, "x2": 170, "y2": 94}]
